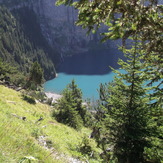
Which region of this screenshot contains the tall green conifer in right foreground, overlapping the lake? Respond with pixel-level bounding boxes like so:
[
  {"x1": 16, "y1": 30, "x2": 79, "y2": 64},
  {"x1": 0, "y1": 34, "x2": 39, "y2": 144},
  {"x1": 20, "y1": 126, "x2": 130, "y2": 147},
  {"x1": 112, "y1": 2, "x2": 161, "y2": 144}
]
[{"x1": 92, "y1": 41, "x2": 161, "y2": 163}]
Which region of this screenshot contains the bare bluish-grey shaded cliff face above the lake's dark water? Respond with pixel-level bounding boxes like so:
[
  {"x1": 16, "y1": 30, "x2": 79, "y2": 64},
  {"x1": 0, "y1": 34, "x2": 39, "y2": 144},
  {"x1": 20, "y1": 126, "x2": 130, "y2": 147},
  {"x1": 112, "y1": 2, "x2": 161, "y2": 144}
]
[{"x1": 31, "y1": 0, "x2": 92, "y2": 57}]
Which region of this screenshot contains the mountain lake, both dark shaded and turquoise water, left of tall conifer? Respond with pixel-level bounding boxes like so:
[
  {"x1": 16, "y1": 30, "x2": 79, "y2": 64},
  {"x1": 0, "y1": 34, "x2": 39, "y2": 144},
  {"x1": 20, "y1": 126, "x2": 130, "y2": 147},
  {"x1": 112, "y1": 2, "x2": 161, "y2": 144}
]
[{"x1": 44, "y1": 49, "x2": 123, "y2": 100}]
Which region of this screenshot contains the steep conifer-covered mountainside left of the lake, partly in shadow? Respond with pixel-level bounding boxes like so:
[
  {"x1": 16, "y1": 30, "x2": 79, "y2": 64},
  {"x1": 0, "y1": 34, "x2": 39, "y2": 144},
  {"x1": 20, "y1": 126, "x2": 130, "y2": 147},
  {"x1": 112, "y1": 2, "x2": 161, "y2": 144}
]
[{"x1": 0, "y1": 7, "x2": 57, "y2": 79}]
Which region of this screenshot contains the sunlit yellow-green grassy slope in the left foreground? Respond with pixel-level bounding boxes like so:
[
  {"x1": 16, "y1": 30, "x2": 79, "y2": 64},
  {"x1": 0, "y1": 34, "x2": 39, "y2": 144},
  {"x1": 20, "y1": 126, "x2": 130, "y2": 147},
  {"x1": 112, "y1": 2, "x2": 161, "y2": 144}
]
[{"x1": 0, "y1": 85, "x2": 94, "y2": 163}]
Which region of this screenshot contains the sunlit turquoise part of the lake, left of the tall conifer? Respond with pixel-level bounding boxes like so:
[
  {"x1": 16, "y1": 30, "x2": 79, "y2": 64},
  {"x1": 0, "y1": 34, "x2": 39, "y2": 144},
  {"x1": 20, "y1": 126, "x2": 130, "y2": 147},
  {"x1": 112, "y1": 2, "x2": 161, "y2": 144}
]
[{"x1": 44, "y1": 72, "x2": 118, "y2": 99}]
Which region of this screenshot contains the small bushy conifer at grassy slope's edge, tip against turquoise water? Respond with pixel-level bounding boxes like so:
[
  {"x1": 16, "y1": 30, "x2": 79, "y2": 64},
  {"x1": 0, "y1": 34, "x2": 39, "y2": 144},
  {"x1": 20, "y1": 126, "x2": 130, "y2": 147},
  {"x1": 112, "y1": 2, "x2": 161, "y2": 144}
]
[{"x1": 53, "y1": 80, "x2": 88, "y2": 130}]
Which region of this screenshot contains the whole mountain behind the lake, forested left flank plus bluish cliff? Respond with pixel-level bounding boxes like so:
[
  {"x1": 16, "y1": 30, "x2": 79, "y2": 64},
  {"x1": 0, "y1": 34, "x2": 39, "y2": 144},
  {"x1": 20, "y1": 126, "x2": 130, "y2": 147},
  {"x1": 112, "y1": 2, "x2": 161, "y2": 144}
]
[{"x1": 0, "y1": 0, "x2": 119, "y2": 80}]
